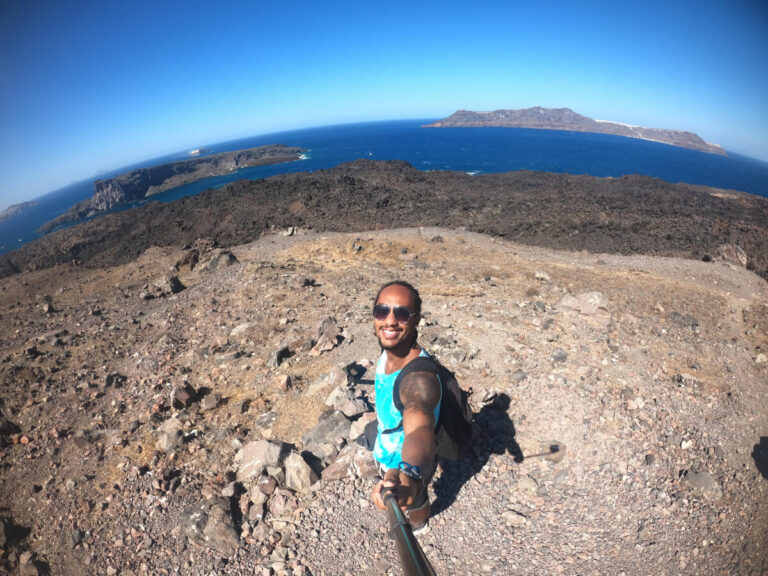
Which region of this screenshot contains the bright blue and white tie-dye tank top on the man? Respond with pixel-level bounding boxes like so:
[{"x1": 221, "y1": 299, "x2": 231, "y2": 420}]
[{"x1": 373, "y1": 348, "x2": 442, "y2": 469}]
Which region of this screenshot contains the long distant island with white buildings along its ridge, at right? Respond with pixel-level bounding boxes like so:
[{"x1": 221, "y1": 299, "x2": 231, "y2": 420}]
[{"x1": 424, "y1": 106, "x2": 727, "y2": 156}]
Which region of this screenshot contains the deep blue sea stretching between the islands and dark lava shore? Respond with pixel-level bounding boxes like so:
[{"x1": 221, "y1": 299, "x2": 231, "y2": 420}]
[{"x1": 0, "y1": 119, "x2": 768, "y2": 253}]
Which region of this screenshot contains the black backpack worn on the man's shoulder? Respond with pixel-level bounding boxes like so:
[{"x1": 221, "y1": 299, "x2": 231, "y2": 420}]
[{"x1": 392, "y1": 356, "x2": 472, "y2": 460}]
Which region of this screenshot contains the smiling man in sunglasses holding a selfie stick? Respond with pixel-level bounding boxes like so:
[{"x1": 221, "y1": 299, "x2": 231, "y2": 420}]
[{"x1": 372, "y1": 281, "x2": 441, "y2": 533}]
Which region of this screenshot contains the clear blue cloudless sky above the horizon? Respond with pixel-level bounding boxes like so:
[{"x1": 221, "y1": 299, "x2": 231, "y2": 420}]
[{"x1": 0, "y1": 0, "x2": 768, "y2": 209}]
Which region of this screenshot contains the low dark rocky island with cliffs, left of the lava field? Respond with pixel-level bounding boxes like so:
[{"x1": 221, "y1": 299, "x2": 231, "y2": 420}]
[{"x1": 39, "y1": 144, "x2": 304, "y2": 232}]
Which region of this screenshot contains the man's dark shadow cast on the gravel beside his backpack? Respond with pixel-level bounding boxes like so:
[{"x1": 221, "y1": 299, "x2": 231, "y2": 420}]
[{"x1": 432, "y1": 394, "x2": 524, "y2": 516}]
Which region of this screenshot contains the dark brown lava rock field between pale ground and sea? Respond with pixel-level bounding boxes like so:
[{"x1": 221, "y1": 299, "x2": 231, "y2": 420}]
[{"x1": 0, "y1": 160, "x2": 768, "y2": 278}]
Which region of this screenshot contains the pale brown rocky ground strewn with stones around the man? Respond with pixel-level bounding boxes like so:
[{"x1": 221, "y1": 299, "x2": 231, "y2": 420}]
[{"x1": 0, "y1": 228, "x2": 768, "y2": 576}]
